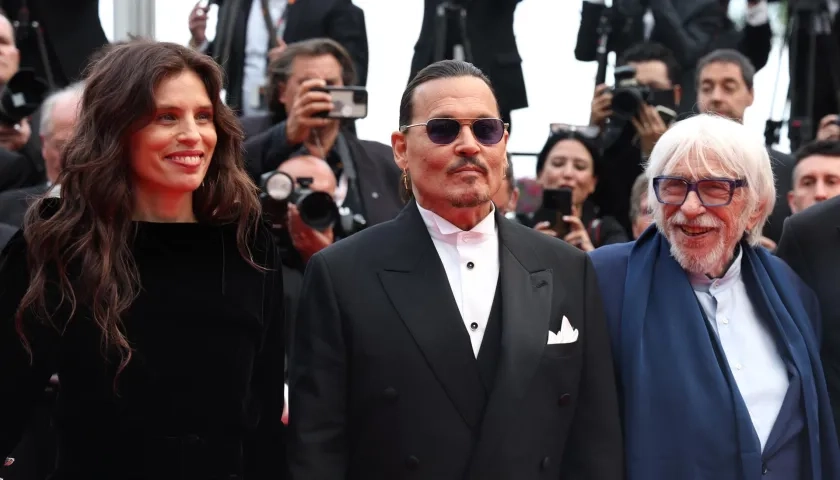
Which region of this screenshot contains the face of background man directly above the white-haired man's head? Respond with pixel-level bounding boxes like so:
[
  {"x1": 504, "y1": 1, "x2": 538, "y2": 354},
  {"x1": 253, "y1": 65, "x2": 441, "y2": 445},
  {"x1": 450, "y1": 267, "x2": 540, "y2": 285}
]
[{"x1": 697, "y1": 62, "x2": 753, "y2": 122}]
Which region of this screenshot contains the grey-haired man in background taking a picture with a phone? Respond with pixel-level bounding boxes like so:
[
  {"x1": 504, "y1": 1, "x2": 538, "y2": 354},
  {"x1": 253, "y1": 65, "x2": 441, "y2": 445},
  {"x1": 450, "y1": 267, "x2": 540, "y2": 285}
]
[{"x1": 245, "y1": 38, "x2": 403, "y2": 229}]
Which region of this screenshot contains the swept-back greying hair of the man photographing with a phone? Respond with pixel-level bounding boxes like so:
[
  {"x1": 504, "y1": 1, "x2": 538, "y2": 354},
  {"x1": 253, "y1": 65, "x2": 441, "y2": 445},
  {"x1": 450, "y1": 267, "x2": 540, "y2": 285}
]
[{"x1": 265, "y1": 38, "x2": 356, "y2": 118}]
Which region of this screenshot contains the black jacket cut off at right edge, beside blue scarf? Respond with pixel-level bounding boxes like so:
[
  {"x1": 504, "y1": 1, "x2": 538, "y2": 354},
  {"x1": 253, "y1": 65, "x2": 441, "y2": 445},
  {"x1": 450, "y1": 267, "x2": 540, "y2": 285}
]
[{"x1": 776, "y1": 193, "x2": 840, "y2": 440}]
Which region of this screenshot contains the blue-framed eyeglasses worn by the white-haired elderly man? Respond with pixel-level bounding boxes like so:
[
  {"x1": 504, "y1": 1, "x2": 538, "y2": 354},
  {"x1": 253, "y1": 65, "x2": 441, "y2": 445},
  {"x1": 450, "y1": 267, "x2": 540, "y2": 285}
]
[{"x1": 653, "y1": 176, "x2": 747, "y2": 207}]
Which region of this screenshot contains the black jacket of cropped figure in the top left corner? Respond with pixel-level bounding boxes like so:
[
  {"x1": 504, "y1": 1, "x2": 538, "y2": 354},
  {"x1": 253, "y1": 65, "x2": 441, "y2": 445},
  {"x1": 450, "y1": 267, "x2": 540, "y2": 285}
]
[{"x1": 0, "y1": 0, "x2": 108, "y2": 87}]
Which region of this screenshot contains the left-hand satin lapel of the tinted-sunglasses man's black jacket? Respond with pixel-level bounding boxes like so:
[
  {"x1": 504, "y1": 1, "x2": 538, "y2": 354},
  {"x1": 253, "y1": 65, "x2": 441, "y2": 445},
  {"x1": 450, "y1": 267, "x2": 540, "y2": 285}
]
[{"x1": 379, "y1": 202, "x2": 486, "y2": 428}]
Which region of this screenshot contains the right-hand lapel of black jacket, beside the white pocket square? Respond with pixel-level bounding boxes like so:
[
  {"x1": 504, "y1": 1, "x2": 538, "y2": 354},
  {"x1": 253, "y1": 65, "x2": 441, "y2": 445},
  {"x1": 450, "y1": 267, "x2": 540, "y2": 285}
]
[{"x1": 472, "y1": 215, "x2": 563, "y2": 478}]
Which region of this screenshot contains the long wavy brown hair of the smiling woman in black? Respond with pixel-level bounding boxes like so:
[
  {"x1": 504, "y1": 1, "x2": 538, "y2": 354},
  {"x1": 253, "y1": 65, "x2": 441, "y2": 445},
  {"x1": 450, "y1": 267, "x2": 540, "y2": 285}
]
[{"x1": 16, "y1": 40, "x2": 261, "y2": 375}]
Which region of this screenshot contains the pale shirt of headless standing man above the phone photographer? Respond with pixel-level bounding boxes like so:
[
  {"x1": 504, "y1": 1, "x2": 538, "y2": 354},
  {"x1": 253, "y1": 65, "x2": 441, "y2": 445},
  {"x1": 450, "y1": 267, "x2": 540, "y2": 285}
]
[{"x1": 242, "y1": 0, "x2": 287, "y2": 115}]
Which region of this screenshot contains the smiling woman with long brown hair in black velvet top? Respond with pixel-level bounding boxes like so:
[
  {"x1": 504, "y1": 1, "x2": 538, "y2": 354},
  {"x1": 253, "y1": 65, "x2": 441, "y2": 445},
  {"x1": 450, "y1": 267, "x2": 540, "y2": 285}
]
[{"x1": 0, "y1": 41, "x2": 285, "y2": 480}]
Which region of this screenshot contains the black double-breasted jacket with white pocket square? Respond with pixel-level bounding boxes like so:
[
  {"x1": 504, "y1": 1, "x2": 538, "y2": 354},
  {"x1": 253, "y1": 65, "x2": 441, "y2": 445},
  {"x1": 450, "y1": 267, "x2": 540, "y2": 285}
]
[{"x1": 289, "y1": 201, "x2": 623, "y2": 480}]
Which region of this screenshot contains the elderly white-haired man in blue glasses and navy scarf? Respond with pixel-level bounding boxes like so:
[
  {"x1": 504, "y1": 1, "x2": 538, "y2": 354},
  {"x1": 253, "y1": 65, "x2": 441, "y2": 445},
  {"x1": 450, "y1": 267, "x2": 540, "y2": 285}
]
[{"x1": 590, "y1": 115, "x2": 840, "y2": 480}]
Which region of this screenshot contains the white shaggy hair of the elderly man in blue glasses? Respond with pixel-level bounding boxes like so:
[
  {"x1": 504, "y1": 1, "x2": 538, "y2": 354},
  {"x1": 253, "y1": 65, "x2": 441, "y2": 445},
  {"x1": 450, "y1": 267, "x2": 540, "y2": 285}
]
[{"x1": 645, "y1": 114, "x2": 776, "y2": 246}]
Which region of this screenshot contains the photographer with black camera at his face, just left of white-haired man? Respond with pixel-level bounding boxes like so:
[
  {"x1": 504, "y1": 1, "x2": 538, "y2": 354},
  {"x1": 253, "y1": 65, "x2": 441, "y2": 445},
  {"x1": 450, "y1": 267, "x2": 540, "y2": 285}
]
[{"x1": 590, "y1": 43, "x2": 682, "y2": 235}]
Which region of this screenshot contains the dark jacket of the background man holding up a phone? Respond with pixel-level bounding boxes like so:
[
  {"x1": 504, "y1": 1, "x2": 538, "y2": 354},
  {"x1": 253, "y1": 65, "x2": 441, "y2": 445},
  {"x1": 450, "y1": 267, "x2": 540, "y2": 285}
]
[{"x1": 245, "y1": 121, "x2": 404, "y2": 225}]
